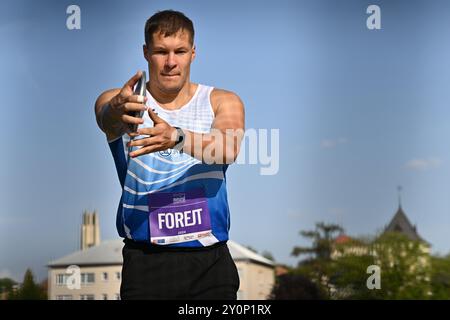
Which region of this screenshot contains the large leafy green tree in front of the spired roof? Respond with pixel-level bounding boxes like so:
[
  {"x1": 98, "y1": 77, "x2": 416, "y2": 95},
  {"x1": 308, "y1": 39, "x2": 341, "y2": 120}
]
[{"x1": 330, "y1": 232, "x2": 431, "y2": 299}]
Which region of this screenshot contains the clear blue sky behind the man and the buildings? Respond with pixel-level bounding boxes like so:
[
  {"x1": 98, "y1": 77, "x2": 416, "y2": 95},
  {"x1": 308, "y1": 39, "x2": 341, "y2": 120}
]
[{"x1": 0, "y1": 0, "x2": 450, "y2": 280}]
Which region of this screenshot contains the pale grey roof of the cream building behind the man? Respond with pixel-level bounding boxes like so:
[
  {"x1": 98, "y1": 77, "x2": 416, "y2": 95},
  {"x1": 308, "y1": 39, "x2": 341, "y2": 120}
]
[{"x1": 48, "y1": 239, "x2": 275, "y2": 268}]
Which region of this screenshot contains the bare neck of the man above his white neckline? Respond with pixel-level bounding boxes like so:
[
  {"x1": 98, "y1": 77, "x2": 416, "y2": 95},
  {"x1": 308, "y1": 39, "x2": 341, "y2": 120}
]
[{"x1": 147, "y1": 81, "x2": 197, "y2": 110}]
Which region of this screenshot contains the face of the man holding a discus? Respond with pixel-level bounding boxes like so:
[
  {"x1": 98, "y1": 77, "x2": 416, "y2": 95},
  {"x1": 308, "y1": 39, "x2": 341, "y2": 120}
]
[{"x1": 144, "y1": 30, "x2": 195, "y2": 93}]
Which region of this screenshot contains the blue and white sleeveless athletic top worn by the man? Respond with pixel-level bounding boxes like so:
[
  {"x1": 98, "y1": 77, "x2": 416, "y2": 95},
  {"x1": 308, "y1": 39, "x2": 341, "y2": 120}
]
[{"x1": 109, "y1": 84, "x2": 230, "y2": 247}]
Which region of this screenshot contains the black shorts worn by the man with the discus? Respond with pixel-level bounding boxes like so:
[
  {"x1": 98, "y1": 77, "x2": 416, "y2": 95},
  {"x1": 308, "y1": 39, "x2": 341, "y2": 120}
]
[{"x1": 120, "y1": 239, "x2": 239, "y2": 300}]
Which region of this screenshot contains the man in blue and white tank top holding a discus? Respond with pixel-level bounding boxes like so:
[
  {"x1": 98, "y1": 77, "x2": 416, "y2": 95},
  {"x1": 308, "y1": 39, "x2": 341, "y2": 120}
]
[{"x1": 95, "y1": 10, "x2": 244, "y2": 299}]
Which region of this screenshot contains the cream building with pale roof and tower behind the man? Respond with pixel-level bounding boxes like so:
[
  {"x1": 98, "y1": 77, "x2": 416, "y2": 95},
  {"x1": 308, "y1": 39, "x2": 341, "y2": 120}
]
[{"x1": 48, "y1": 212, "x2": 275, "y2": 300}]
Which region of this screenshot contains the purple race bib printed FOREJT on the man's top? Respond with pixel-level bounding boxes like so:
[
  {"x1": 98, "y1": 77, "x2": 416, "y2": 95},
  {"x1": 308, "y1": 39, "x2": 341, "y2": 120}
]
[{"x1": 148, "y1": 189, "x2": 211, "y2": 245}]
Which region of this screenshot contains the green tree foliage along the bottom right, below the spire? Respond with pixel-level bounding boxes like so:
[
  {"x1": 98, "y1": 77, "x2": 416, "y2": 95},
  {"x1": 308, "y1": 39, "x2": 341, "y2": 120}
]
[{"x1": 292, "y1": 223, "x2": 450, "y2": 299}]
